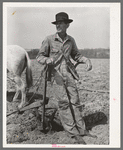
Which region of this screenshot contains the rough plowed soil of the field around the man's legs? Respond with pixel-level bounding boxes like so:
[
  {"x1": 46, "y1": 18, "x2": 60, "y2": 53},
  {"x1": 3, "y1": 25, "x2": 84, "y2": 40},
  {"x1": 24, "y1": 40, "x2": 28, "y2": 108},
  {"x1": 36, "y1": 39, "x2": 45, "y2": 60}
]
[{"x1": 6, "y1": 59, "x2": 110, "y2": 145}]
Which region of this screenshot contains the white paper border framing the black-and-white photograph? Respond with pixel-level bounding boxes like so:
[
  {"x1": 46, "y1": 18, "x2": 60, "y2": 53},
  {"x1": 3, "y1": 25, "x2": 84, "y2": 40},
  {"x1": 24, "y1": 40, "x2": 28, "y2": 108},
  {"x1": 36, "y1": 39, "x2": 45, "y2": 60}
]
[{"x1": 3, "y1": 2, "x2": 121, "y2": 148}]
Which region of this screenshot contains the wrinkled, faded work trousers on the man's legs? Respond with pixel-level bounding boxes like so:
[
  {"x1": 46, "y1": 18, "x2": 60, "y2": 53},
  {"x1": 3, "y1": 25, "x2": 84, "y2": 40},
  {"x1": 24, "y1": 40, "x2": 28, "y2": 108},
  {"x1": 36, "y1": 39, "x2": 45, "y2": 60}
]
[{"x1": 53, "y1": 70, "x2": 85, "y2": 137}]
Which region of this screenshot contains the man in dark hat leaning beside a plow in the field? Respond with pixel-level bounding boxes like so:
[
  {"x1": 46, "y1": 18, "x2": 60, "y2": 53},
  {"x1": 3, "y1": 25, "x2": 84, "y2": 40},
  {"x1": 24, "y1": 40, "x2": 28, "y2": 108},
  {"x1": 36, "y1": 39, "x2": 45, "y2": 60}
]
[{"x1": 36, "y1": 12, "x2": 92, "y2": 144}]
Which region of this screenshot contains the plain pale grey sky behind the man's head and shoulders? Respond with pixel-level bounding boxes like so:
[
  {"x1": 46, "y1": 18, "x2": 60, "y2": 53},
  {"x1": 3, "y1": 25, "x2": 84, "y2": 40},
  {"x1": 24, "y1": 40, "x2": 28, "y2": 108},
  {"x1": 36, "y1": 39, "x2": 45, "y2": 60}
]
[{"x1": 7, "y1": 5, "x2": 110, "y2": 49}]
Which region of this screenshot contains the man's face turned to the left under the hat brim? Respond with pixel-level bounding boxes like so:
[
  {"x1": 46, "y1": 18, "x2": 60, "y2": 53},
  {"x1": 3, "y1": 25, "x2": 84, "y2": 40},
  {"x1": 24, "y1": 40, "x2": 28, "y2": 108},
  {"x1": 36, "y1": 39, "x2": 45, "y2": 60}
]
[{"x1": 56, "y1": 21, "x2": 69, "y2": 33}]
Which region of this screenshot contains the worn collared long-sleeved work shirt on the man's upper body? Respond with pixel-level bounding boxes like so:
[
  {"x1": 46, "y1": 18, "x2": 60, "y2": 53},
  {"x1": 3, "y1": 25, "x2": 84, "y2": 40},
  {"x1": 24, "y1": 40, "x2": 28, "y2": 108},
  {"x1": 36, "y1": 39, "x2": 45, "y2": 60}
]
[{"x1": 36, "y1": 33, "x2": 82, "y2": 79}]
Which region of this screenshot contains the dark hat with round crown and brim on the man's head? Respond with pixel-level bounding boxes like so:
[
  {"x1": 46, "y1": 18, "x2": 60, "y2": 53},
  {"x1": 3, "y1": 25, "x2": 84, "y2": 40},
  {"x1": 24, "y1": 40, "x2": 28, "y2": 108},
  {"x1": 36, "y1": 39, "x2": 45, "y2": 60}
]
[{"x1": 52, "y1": 12, "x2": 73, "y2": 24}]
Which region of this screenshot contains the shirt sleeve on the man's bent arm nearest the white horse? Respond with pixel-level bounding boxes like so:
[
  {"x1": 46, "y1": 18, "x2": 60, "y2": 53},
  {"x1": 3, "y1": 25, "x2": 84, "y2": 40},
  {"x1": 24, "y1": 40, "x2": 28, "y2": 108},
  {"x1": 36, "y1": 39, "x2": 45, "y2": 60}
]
[{"x1": 36, "y1": 37, "x2": 50, "y2": 65}]
